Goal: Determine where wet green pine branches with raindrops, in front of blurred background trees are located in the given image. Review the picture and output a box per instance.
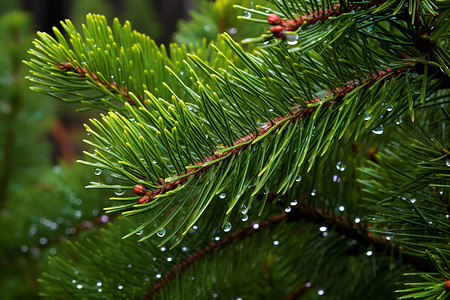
[27,0,450,299]
